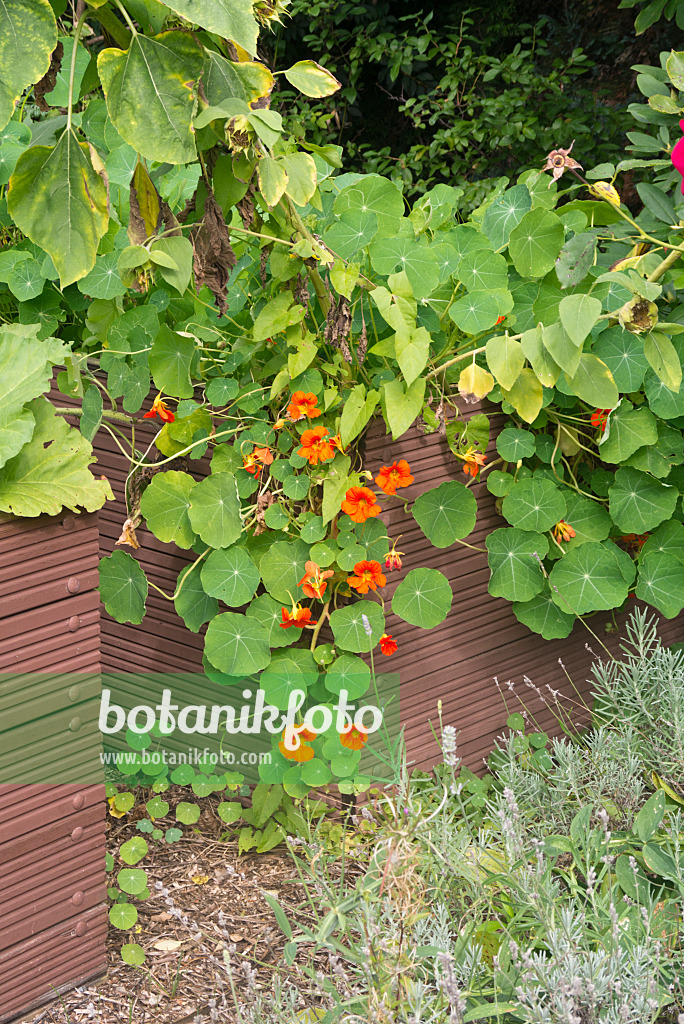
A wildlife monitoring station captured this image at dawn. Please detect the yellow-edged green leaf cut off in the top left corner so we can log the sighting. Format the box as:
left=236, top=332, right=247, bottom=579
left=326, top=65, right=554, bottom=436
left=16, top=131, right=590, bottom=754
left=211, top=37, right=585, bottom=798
left=0, top=0, right=57, bottom=128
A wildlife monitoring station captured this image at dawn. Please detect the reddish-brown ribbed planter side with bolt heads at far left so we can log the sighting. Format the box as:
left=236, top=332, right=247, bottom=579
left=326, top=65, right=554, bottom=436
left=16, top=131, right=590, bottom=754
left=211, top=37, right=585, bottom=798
left=0, top=513, right=106, bottom=1022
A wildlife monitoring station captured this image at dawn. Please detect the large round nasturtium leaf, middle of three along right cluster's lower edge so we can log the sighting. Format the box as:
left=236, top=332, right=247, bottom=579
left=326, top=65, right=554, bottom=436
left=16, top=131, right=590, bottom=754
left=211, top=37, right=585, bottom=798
left=549, top=542, right=630, bottom=615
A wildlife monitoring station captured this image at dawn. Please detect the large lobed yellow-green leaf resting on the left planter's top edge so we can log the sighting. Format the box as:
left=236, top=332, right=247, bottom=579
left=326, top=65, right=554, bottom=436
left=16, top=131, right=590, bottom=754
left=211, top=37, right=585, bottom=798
left=0, top=395, right=113, bottom=518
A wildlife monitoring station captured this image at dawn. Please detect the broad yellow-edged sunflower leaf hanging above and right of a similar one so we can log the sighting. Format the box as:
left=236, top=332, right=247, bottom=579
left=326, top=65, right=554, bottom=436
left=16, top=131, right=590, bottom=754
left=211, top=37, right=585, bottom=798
left=97, top=32, right=202, bottom=164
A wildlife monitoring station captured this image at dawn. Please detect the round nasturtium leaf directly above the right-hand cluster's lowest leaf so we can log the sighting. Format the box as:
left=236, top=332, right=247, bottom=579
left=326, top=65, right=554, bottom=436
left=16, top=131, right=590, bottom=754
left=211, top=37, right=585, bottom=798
left=484, top=527, right=549, bottom=601
